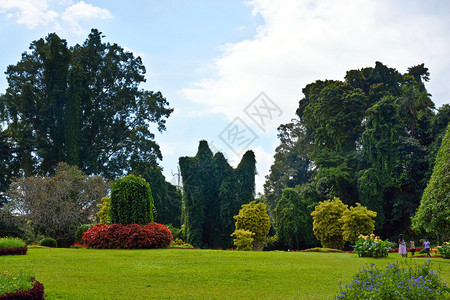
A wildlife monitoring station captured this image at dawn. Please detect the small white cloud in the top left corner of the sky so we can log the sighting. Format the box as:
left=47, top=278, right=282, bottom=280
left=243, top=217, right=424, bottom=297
left=0, top=0, right=112, bottom=35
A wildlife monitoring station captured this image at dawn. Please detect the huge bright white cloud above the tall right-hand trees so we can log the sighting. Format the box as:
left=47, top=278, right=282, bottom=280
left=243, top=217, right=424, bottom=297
left=182, top=0, right=450, bottom=129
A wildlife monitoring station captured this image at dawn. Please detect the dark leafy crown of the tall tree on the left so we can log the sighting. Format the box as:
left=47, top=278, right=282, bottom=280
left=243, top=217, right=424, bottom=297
left=0, top=29, right=173, bottom=183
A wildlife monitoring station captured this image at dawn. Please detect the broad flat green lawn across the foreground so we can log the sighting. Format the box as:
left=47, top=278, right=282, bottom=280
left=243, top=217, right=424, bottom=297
left=0, top=248, right=450, bottom=299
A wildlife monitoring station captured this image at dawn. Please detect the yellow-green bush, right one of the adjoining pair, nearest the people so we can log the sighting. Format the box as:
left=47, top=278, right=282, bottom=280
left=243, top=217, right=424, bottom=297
left=339, top=203, right=377, bottom=243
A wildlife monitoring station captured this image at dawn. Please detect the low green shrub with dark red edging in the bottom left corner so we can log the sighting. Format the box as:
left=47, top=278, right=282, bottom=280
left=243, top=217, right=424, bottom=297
left=0, top=271, right=44, bottom=300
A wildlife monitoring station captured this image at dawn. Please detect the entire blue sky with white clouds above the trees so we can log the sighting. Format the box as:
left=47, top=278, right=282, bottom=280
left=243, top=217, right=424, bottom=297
left=0, top=0, right=450, bottom=192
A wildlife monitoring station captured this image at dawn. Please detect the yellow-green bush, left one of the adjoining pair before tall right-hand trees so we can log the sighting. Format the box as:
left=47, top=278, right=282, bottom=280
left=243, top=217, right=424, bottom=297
left=311, top=198, right=348, bottom=250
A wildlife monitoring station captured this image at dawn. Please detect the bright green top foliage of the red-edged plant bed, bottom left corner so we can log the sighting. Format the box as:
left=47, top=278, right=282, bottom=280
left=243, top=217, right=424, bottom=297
left=0, top=271, right=34, bottom=299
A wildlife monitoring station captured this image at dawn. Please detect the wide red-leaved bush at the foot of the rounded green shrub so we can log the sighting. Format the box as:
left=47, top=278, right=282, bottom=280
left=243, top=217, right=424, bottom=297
left=83, top=223, right=173, bottom=249
